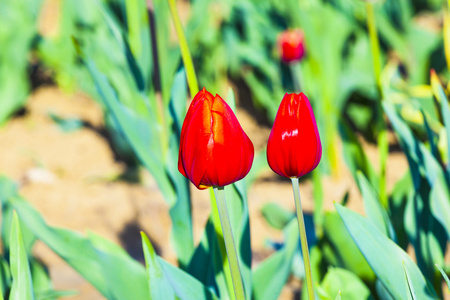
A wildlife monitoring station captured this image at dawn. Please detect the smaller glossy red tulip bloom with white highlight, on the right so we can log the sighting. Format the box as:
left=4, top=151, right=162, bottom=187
left=267, top=93, right=322, bottom=178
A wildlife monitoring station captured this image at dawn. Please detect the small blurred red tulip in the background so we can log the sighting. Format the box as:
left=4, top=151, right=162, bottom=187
left=278, top=29, right=305, bottom=63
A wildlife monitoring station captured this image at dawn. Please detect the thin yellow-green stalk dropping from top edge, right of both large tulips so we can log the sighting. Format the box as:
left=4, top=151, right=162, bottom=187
left=366, top=1, right=389, bottom=207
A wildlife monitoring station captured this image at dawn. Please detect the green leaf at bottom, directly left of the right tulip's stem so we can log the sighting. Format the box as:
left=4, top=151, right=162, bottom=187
left=253, top=218, right=299, bottom=300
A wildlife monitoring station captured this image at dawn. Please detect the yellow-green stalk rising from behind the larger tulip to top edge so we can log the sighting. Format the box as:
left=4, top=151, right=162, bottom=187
left=167, top=0, right=199, bottom=97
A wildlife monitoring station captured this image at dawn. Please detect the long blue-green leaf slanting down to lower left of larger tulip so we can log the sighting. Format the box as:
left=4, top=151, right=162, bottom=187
left=86, top=60, right=194, bottom=267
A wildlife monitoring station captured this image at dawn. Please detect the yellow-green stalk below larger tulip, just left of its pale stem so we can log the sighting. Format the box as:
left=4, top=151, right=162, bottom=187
left=208, top=188, right=235, bottom=300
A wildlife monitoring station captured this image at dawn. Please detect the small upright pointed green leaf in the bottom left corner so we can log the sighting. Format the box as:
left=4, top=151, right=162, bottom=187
left=9, top=212, right=34, bottom=300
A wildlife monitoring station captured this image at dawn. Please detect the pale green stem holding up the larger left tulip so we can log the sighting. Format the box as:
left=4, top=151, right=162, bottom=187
left=214, top=186, right=245, bottom=300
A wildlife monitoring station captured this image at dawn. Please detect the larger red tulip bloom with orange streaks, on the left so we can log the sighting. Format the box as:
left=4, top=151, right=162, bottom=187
left=178, top=88, right=254, bottom=189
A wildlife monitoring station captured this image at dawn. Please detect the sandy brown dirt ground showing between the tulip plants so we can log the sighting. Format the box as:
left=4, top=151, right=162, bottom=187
left=0, top=87, right=426, bottom=300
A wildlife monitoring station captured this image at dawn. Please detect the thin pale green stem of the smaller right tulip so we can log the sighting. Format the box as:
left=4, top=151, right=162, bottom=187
left=291, top=177, right=314, bottom=300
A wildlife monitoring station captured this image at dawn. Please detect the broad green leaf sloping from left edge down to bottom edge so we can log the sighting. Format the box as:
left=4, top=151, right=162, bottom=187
left=2, top=179, right=149, bottom=299
